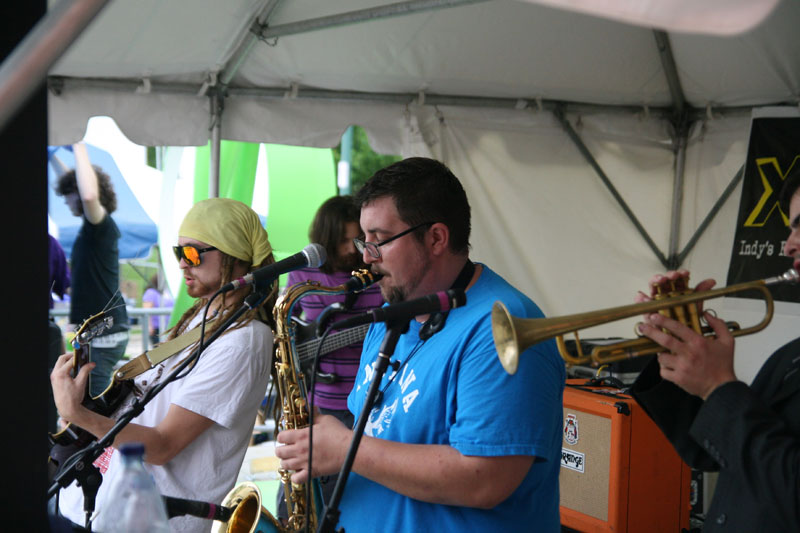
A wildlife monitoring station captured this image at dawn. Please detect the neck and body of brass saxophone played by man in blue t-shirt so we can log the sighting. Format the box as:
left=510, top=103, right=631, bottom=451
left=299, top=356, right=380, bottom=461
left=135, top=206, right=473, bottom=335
left=273, top=270, right=381, bottom=532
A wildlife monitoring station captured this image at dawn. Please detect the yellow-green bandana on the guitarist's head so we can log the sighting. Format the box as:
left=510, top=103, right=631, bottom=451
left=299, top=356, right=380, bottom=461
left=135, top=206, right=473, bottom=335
left=178, top=198, right=272, bottom=267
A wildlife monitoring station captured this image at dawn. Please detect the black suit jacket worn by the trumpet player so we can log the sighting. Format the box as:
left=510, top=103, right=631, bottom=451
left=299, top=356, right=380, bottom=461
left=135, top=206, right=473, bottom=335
left=632, top=339, right=800, bottom=531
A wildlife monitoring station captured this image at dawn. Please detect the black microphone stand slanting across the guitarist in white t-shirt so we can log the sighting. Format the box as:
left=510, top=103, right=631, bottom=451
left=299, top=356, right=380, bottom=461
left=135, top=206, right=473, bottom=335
left=47, top=287, right=269, bottom=531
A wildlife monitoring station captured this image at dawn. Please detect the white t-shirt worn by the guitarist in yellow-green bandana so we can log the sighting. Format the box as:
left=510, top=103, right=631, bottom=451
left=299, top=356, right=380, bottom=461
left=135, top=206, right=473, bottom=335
left=59, top=316, right=273, bottom=532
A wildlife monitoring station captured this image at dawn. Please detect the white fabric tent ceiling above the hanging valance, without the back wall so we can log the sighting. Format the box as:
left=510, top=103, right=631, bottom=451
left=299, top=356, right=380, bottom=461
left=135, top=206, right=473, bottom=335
left=50, top=0, right=800, bottom=147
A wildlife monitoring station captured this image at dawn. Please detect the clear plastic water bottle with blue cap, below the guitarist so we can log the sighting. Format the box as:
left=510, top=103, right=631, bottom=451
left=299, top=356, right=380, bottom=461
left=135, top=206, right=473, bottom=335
left=102, top=442, right=170, bottom=533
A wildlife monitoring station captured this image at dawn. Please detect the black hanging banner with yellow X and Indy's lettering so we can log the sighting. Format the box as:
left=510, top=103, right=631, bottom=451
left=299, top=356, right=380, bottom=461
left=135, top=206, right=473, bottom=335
left=727, top=113, right=800, bottom=302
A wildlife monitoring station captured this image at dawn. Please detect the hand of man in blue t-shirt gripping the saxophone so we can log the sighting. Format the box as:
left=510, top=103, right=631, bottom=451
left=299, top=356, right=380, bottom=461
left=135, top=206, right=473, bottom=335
left=275, top=412, right=353, bottom=483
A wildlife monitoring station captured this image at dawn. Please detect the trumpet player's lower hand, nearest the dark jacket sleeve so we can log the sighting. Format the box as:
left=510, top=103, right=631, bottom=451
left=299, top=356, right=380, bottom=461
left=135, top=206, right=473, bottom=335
left=639, top=312, right=736, bottom=400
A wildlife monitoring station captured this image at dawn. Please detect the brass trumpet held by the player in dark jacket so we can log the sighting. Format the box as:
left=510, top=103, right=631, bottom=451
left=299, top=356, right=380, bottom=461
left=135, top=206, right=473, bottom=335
left=492, top=268, right=800, bottom=374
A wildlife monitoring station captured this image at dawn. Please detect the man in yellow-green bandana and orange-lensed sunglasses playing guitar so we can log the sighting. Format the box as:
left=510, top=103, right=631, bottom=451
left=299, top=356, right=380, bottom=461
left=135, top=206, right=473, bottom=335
left=50, top=198, right=277, bottom=531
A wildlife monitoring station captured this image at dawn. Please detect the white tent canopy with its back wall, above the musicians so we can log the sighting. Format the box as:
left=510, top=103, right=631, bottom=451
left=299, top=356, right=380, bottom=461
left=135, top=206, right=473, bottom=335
left=48, top=0, right=800, bottom=379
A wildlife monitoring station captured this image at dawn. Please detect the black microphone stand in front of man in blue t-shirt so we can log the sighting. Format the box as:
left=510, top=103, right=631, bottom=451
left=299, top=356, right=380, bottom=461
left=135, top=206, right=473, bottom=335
left=318, top=319, right=411, bottom=533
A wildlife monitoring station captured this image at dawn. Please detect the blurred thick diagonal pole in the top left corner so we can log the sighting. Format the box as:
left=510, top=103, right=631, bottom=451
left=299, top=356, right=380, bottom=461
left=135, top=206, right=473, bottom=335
left=0, top=0, right=108, bottom=130
